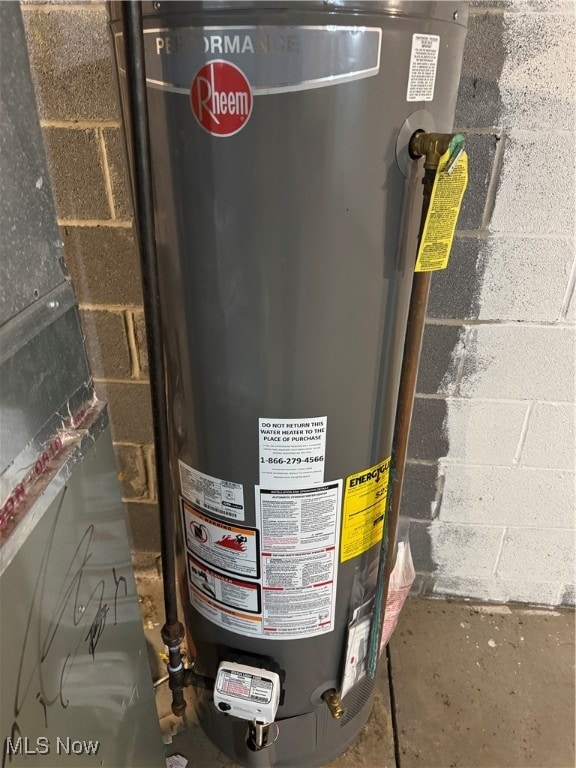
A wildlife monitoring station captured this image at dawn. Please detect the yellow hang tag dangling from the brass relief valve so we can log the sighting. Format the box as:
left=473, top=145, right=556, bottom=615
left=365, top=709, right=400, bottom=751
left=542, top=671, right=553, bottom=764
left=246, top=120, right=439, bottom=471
left=414, top=149, right=468, bottom=272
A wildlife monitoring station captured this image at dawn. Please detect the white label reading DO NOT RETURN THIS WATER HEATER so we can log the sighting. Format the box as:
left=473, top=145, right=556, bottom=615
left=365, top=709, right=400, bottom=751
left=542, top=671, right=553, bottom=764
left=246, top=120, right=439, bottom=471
left=258, top=416, right=327, bottom=488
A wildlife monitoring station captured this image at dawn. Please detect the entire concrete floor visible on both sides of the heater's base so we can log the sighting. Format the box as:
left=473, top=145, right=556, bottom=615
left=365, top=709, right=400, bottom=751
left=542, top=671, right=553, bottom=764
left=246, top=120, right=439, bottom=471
left=139, top=578, right=575, bottom=768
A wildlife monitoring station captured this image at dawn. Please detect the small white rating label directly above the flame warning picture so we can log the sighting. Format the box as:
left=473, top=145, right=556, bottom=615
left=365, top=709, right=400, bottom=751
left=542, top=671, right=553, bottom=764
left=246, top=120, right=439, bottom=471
left=178, top=460, right=244, bottom=520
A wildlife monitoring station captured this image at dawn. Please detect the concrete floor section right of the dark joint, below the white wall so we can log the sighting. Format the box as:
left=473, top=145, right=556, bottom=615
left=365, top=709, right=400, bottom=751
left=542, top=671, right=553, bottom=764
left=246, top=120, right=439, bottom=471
left=391, top=599, right=575, bottom=768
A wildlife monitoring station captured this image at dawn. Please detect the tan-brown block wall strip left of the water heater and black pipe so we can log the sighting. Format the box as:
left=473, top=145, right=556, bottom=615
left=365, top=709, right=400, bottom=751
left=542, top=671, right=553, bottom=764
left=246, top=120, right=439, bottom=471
left=21, top=2, right=159, bottom=554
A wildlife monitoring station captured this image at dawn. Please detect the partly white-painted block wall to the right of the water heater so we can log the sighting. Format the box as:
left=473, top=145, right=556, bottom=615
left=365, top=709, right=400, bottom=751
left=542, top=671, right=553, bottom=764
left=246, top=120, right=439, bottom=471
left=403, top=0, right=576, bottom=605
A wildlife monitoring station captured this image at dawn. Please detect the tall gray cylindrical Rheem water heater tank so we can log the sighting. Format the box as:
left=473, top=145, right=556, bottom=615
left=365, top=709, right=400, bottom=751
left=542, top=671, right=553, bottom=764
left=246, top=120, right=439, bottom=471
left=112, top=2, right=466, bottom=766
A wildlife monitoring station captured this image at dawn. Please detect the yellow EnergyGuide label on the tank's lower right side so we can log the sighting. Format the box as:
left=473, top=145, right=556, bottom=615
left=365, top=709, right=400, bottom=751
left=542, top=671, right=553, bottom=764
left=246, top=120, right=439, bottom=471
left=340, top=458, right=390, bottom=563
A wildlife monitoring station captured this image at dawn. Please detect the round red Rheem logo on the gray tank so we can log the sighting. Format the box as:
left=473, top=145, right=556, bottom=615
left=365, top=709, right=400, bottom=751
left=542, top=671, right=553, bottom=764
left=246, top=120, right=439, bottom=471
left=190, top=59, right=253, bottom=136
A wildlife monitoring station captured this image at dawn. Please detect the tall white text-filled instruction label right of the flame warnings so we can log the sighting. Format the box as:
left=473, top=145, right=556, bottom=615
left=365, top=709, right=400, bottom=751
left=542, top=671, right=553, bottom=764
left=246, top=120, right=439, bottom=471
left=256, top=480, right=342, bottom=639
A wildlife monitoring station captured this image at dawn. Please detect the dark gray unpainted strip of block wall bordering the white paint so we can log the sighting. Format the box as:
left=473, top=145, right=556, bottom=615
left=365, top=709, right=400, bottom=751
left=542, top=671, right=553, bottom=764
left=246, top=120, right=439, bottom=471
left=401, top=11, right=506, bottom=592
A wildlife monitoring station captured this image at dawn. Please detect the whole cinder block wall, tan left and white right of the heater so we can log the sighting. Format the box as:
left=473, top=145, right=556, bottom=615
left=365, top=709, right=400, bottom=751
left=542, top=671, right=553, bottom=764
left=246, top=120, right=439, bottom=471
left=22, top=0, right=576, bottom=605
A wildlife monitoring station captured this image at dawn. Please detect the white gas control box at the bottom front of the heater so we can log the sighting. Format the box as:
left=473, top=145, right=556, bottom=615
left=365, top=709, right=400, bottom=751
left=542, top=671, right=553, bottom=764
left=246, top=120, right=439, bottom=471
left=214, top=661, right=281, bottom=751
